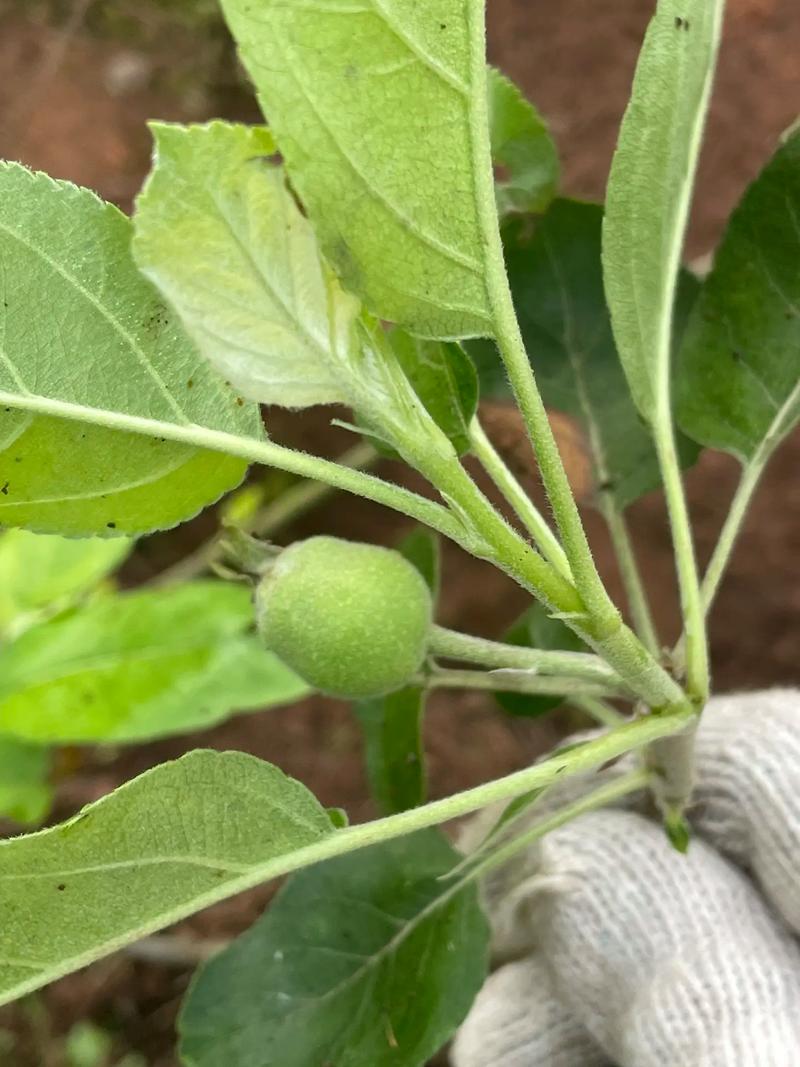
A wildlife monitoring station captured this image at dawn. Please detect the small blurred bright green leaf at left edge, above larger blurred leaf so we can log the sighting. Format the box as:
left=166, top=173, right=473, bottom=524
left=0, top=529, right=132, bottom=631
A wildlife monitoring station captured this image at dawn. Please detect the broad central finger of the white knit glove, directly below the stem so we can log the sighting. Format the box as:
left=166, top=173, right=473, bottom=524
left=532, top=811, right=800, bottom=1067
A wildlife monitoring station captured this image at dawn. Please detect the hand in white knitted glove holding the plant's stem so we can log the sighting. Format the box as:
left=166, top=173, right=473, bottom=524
left=451, top=689, right=800, bottom=1067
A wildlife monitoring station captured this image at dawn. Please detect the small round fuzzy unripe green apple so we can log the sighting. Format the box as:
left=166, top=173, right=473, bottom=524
left=256, top=537, right=432, bottom=700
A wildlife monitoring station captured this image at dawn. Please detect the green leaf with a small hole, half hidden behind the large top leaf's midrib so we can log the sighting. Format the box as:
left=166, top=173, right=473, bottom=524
left=489, top=67, right=561, bottom=219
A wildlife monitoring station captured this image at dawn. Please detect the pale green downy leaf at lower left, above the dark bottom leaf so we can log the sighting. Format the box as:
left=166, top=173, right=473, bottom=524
left=0, top=751, right=334, bottom=1003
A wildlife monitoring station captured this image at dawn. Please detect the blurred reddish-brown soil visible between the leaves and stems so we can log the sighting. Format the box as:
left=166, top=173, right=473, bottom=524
left=0, top=0, right=800, bottom=1067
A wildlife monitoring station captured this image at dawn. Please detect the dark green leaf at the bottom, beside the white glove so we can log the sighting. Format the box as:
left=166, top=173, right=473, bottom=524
left=180, top=831, right=489, bottom=1067
